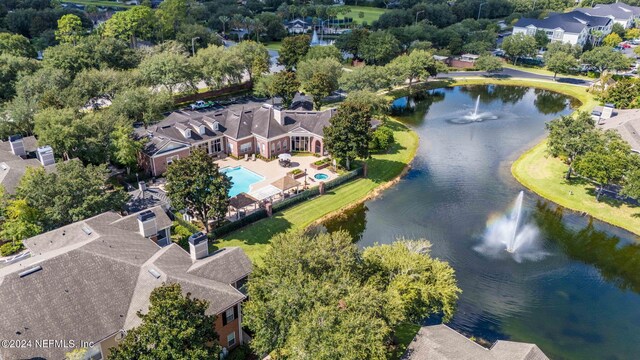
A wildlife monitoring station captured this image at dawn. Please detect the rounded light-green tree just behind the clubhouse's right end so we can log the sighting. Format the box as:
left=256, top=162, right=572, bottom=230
left=297, top=58, right=342, bottom=110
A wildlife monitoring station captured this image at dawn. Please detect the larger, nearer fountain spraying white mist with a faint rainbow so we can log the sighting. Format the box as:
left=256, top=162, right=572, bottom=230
left=475, top=191, right=546, bottom=262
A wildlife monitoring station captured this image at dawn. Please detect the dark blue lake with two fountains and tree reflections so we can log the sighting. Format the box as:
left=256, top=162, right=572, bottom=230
left=324, top=85, right=640, bottom=359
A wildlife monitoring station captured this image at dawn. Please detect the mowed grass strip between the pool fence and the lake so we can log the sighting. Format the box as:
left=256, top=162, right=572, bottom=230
left=214, top=121, right=418, bottom=262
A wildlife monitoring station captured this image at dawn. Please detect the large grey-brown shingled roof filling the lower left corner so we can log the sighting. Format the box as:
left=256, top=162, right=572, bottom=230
left=0, top=208, right=251, bottom=359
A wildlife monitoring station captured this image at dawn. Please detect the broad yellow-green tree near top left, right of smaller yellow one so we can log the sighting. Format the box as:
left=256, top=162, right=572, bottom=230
left=103, top=6, right=155, bottom=48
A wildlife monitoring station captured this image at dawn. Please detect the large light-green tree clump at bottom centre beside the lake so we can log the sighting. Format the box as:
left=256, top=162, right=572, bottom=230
left=243, top=231, right=459, bottom=360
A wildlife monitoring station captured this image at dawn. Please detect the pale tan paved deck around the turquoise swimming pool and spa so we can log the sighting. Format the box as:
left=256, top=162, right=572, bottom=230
left=216, top=155, right=338, bottom=192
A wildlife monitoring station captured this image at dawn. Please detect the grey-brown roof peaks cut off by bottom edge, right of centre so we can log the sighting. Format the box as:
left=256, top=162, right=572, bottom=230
left=402, top=324, right=549, bottom=360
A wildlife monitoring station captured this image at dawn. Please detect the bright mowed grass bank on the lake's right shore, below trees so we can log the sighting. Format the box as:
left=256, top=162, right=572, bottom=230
left=511, top=141, right=640, bottom=234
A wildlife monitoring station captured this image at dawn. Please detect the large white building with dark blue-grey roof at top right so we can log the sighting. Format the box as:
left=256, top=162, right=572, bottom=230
left=513, top=11, right=613, bottom=46
